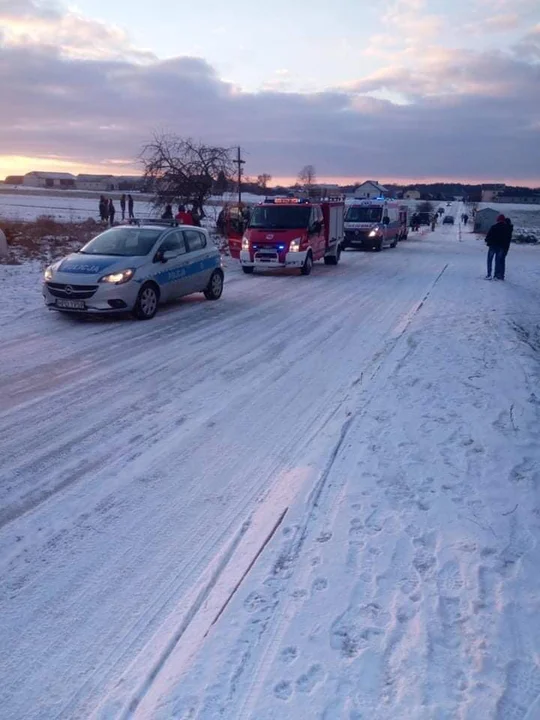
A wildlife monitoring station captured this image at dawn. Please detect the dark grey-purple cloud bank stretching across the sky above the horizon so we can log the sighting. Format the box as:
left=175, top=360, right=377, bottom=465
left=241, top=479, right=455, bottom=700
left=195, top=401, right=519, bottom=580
left=0, top=29, right=540, bottom=180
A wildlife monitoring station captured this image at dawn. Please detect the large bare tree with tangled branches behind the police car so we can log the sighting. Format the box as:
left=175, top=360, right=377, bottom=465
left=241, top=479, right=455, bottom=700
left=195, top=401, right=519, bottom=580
left=140, top=134, right=234, bottom=217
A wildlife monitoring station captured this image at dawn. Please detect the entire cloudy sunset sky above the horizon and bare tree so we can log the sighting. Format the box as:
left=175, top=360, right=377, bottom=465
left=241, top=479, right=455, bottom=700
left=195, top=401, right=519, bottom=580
left=0, top=0, right=540, bottom=185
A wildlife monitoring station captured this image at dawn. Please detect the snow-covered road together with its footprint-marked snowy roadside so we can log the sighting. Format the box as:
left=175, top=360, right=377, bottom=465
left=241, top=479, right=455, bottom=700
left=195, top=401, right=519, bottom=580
left=0, top=207, right=540, bottom=720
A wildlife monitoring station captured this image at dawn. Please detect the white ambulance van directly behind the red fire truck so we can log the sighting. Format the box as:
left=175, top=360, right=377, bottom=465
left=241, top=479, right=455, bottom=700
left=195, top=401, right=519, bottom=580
left=343, top=198, right=407, bottom=251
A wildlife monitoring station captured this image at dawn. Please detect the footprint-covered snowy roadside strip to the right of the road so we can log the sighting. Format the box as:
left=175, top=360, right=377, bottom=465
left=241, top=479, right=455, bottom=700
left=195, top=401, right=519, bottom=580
left=136, top=245, right=540, bottom=720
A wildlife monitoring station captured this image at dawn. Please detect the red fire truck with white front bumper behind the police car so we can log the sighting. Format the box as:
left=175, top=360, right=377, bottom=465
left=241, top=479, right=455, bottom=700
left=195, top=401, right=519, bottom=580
left=240, top=197, right=345, bottom=275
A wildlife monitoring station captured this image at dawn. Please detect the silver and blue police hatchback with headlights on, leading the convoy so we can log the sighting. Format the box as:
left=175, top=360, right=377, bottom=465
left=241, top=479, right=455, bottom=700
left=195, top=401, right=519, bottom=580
left=43, top=221, right=223, bottom=320
